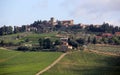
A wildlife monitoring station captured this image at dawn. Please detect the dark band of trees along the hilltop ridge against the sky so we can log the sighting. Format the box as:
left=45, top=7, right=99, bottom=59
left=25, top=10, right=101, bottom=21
left=0, top=20, right=120, bottom=35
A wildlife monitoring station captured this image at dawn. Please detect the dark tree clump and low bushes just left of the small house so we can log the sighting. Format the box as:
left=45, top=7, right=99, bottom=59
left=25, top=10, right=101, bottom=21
left=17, top=38, right=61, bottom=51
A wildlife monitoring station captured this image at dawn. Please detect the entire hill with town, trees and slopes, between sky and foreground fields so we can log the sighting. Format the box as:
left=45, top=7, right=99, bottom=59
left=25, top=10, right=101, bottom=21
left=0, top=17, right=120, bottom=52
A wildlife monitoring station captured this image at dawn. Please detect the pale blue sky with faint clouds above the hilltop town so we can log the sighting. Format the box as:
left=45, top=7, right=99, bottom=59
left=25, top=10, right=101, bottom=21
left=0, top=0, right=120, bottom=26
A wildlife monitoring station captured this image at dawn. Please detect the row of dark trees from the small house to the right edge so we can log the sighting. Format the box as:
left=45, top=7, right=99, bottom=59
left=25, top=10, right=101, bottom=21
left=68, top=36, right=120, bottom=48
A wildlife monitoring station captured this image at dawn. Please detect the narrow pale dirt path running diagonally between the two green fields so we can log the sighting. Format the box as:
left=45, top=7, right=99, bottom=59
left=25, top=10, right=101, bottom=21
left=35, top=53, right=67, bottom=75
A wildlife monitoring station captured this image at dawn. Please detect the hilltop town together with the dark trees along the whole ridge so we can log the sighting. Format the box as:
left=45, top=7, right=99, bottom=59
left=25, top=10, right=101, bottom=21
left=0, top=17, right=120, bottom=35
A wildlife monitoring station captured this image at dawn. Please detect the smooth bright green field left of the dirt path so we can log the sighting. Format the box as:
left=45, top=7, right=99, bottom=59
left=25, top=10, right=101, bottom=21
left=0, top=49, right=62, bottom=75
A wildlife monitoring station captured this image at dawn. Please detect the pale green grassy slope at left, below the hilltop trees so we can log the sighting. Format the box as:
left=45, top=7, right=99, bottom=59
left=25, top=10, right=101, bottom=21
left=0, top=32, right=58, bottom=44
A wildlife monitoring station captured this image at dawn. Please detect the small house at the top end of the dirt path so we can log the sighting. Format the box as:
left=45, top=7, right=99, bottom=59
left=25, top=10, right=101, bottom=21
left=58, top=38, right=72, bottom=52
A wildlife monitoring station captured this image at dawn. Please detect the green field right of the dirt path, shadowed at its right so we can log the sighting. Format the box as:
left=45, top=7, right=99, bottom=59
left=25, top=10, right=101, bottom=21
left=42, top=51, right=120, bottom=75
